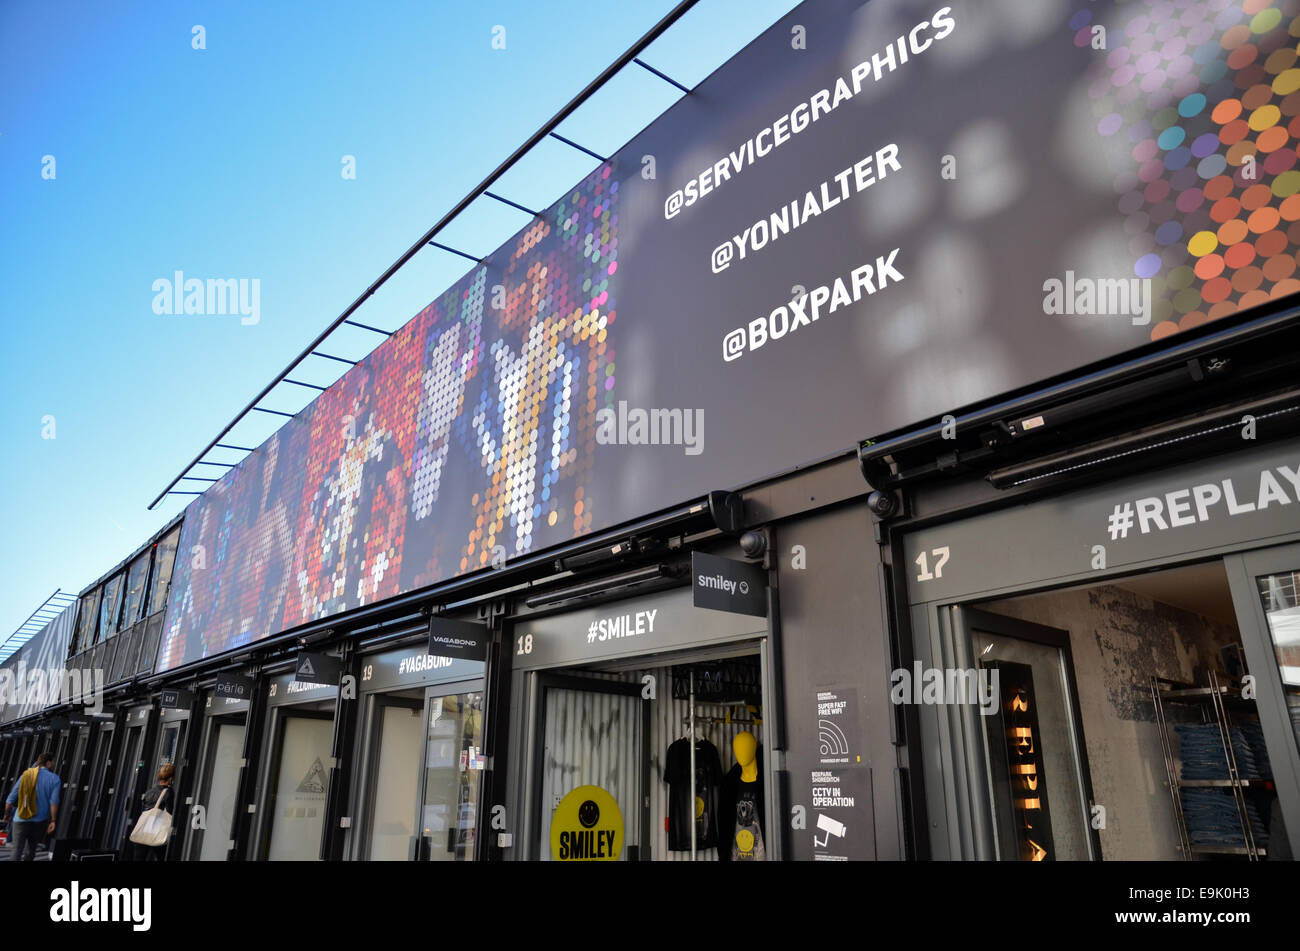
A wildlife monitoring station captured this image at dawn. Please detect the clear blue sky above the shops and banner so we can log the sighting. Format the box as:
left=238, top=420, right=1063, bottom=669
left=0, top=0, right=796, bottom=638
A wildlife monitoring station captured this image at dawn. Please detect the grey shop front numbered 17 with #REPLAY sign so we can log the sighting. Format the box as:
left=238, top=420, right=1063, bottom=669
left=891, top=439, right=1300, bottom=860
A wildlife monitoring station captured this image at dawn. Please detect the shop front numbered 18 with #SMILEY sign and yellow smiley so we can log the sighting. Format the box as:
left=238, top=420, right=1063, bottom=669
left=498, top=571, right=783, bottom=861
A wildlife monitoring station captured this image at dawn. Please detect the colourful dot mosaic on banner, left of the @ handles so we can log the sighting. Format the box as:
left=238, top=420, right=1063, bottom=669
left=156, top=161, right=620, bottom=670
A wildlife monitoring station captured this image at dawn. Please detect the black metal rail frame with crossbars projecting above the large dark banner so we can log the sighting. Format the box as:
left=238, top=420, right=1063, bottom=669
left=148, top=0, right=698, bottom=509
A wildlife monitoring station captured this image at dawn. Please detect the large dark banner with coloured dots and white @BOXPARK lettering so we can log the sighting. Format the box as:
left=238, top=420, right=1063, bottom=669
left=157, top=0, right=1300, bottom=670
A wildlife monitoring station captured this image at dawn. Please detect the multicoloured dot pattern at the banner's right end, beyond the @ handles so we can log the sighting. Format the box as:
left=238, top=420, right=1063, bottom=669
left=1086, top=0, right=1300, bottom=340
